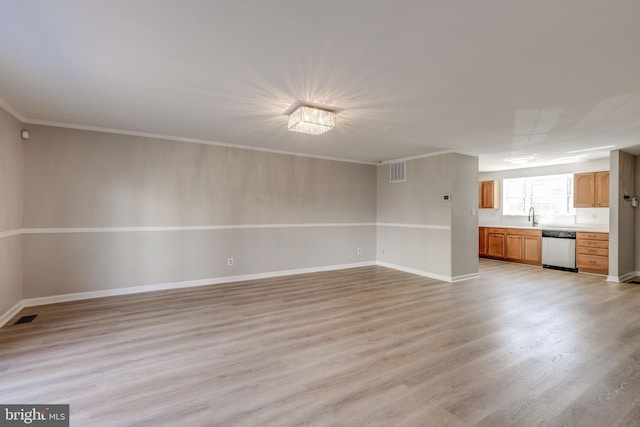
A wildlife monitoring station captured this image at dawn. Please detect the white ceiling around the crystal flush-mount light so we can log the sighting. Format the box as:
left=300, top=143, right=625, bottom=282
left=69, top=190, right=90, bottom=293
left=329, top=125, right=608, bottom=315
left=0, top=0, right=640, bottom=171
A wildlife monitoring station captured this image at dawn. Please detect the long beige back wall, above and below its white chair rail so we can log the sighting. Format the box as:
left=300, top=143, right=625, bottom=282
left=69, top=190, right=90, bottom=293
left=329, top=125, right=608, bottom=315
left=24, top=126, right=376, bottom=298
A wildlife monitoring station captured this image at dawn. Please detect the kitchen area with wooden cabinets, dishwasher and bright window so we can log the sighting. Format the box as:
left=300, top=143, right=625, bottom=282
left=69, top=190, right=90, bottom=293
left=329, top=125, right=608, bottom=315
left=478, top=164, right=608, bottom=276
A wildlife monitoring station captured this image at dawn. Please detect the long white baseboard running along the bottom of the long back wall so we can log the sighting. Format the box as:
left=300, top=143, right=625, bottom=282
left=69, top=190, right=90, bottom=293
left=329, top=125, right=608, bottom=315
left=22, top=261, right=376, bottom=307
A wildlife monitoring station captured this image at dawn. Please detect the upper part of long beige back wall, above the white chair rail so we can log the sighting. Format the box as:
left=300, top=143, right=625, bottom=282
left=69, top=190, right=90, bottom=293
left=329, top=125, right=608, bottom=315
left=25, top=126, right=376, bottom=228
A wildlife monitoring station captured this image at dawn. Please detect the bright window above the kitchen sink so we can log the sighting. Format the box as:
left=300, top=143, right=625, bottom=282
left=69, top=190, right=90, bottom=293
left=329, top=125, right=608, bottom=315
left=502, top=174, right=575, bottom=215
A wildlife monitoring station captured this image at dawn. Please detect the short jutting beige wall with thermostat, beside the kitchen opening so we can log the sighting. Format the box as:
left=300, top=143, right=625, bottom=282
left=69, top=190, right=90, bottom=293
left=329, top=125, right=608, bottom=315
left=377, top=153, right=478, bottom=280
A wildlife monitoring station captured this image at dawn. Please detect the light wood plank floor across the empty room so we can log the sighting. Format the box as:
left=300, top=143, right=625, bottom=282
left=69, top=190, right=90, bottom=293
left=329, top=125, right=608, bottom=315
left=0, top=260, right=640, bottom=427
